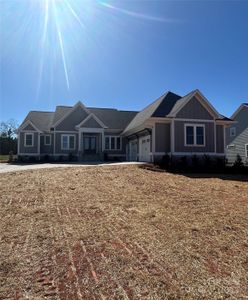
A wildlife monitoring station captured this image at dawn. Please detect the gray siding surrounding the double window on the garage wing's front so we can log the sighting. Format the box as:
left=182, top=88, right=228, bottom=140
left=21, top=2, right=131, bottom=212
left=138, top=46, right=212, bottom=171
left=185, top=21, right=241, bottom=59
left=174, top=121, right=215, bottom=153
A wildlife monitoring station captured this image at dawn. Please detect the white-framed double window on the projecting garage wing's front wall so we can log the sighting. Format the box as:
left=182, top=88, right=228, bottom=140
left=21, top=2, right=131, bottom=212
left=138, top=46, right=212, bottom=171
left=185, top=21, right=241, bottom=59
left=185, top=124, right=205, bottom=146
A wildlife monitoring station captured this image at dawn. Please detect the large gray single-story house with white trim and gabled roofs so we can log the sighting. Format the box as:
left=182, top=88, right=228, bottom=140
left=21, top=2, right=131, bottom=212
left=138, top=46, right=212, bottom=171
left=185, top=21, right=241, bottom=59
left=18, top=90, right=233, bottom=162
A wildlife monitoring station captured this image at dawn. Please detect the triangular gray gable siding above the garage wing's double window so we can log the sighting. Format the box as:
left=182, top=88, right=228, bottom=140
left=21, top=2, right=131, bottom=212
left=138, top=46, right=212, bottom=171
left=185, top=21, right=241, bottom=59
left=176, top=96, right=213, bottom=120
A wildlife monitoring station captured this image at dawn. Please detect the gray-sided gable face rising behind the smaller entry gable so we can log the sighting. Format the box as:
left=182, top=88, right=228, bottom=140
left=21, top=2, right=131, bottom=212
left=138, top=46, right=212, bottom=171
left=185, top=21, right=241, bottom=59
left=56, top=105, right=89, bottom=131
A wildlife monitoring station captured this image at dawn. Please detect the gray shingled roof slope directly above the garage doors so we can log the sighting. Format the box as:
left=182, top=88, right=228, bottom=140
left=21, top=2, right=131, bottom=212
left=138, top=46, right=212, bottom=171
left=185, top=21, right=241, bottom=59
left=124, top=92, right=181, bottom=133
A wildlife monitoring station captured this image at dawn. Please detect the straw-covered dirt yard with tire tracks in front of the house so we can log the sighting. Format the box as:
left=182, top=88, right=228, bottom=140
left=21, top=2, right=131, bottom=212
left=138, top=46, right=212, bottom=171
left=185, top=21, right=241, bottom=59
left=0, top=166, right=248, bottom=300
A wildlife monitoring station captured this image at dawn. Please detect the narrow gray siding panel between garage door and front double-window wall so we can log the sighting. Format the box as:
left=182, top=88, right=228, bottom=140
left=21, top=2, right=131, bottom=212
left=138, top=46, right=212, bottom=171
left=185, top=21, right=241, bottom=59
left=155, top=123, right=170, bottom=153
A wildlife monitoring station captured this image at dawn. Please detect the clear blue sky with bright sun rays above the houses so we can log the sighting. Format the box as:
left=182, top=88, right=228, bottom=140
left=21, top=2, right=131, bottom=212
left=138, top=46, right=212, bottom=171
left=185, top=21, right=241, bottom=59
left=0, top=0, right=248, bottom=123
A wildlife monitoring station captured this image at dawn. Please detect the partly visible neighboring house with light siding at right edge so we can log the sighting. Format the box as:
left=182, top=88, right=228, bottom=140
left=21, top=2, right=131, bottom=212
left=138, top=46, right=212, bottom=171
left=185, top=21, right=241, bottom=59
left=226, top=103, right=248, bottom=164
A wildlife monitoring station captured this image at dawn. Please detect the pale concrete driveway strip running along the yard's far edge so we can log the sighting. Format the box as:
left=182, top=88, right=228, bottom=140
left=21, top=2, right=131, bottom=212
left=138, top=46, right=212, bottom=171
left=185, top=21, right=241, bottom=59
left=0, top=162, right=144, bottom=173
